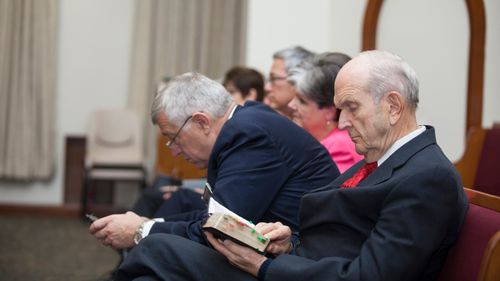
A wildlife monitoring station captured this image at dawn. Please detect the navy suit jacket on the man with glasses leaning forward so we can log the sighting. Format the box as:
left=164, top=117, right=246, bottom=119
left=151, top=102, right=339, bottom=243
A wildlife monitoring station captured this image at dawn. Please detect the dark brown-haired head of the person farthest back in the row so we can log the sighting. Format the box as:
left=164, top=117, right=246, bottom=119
left=222, top=66, right=264, bottom=105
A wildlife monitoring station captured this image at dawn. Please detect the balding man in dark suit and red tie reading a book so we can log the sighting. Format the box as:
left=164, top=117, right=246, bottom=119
left=118, top=51, right=467, bottom=281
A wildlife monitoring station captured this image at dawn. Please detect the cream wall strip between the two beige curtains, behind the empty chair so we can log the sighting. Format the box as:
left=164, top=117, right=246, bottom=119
left=0, top=0, right=134, bottom=205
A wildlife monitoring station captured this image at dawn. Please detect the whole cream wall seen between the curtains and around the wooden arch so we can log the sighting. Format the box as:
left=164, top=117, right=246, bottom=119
left=0, top=0, right=500, bottom=205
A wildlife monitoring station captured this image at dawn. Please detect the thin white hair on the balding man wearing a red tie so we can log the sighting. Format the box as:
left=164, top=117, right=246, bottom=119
left=358, top=50, right=419, bottom=110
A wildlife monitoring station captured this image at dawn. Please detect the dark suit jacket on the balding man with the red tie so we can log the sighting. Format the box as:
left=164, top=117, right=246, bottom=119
left=265, top=127, right=468, bottom=281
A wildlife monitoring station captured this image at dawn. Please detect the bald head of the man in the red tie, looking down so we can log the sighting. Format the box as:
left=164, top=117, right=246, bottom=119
left=334, top=51, right=418, bottom=162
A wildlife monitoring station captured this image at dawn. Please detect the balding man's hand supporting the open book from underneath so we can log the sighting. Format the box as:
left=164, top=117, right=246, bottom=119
left=205, top=232, right=266, bottom=276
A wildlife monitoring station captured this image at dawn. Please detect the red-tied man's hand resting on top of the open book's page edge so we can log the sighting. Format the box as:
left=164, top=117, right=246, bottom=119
left=255, top=222, right=292, bottom=256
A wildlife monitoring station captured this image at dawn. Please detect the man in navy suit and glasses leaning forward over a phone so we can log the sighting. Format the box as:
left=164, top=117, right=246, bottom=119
left=90, top=73, right=339, bottom=249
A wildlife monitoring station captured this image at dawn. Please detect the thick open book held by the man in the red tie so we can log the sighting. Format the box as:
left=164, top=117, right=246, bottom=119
left=203, top=198, right=269, bottom=253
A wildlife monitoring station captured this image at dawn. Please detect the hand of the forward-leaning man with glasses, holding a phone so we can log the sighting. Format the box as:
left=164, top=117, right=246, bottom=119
left=89, top=212, right=147, bottom=250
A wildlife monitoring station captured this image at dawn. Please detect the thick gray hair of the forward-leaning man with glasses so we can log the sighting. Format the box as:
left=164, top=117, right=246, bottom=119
left=151, top=72, right=232, bottom=126
